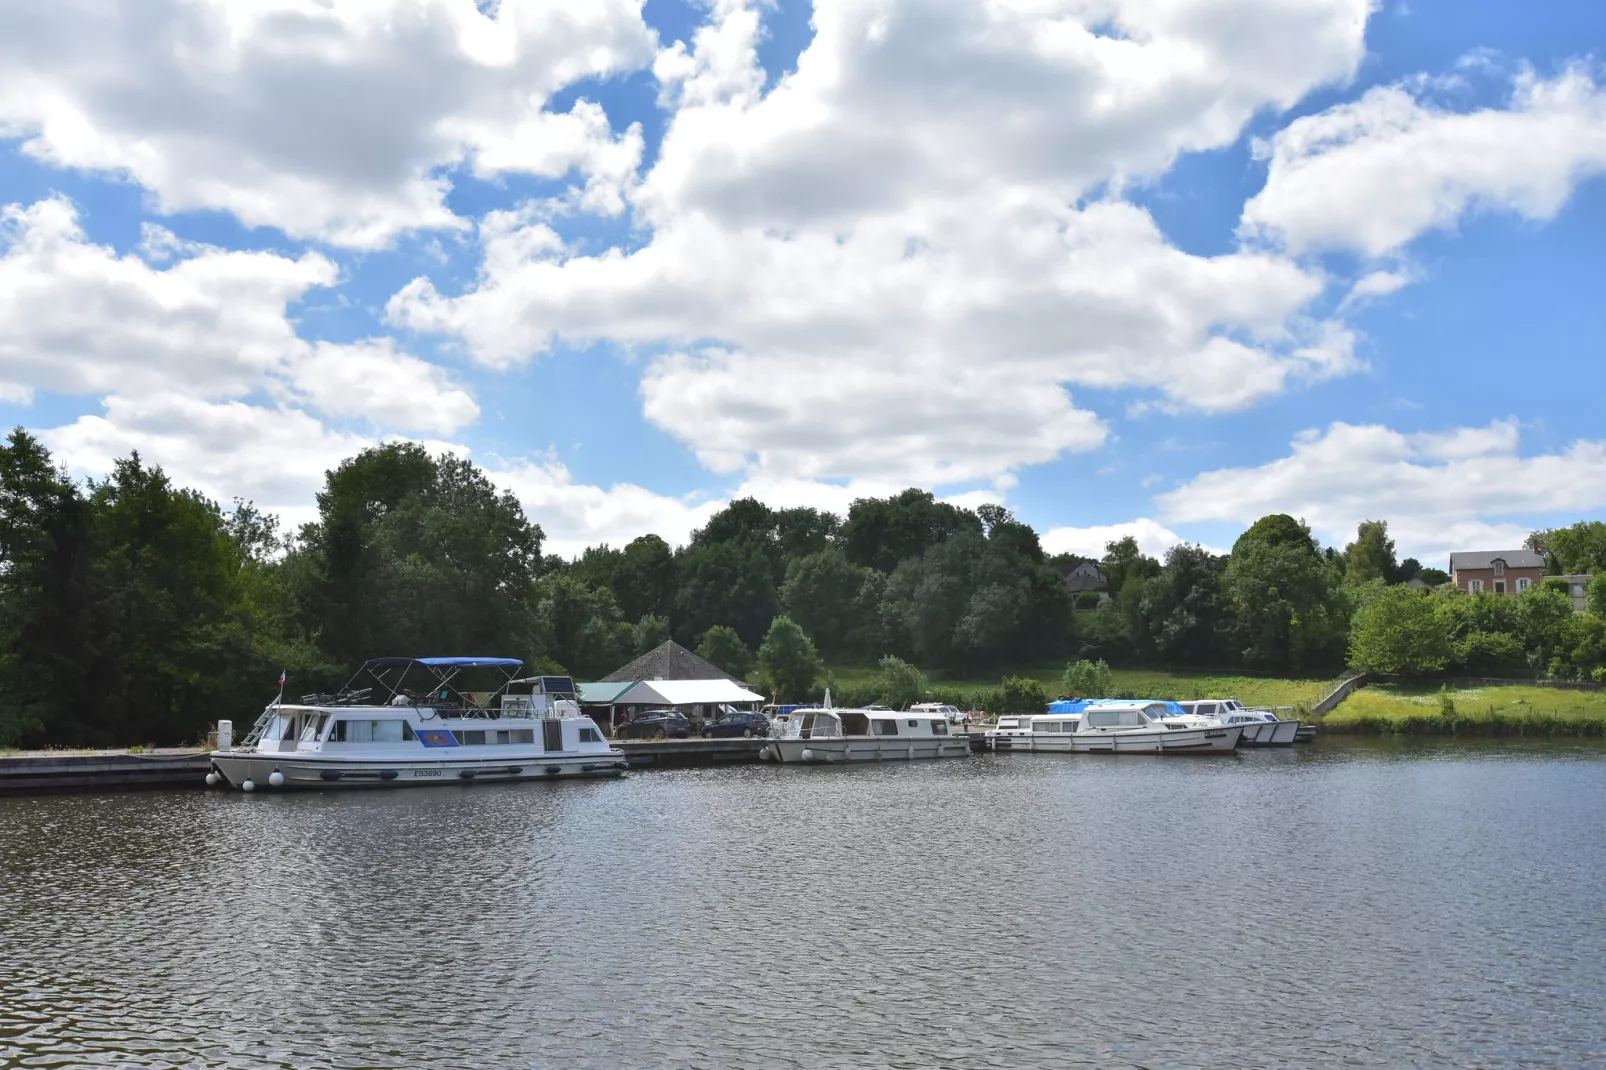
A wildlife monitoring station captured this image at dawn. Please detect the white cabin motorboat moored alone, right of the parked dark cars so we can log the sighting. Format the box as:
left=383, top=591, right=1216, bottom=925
left=758, top=707, right=970, bottom=763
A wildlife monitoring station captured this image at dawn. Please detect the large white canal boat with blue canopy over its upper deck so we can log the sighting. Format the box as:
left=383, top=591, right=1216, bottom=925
left=206, top=657, right=626, bottom=792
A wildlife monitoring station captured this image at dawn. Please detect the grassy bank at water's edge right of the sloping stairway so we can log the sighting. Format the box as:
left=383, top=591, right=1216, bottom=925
left=1322, top=684, right=1606, bottom=736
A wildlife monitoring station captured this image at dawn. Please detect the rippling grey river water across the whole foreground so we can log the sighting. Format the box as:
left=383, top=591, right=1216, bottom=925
left=0, top=741, right=1606, bottom=1068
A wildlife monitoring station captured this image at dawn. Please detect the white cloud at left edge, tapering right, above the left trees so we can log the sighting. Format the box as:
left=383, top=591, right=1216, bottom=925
left=0, top=198, right=479, bottom=434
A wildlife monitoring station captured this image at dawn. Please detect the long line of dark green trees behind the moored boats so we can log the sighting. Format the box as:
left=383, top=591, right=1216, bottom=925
left=0, top=429, right=1606, bottom=745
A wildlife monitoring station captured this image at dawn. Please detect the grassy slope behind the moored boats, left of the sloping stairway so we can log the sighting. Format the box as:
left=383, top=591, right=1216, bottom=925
left=832, top=665, right=1331, bottom=712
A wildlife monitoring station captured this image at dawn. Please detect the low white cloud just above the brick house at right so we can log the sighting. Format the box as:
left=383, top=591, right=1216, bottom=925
left=1156, top=421, right=1606, bottom=564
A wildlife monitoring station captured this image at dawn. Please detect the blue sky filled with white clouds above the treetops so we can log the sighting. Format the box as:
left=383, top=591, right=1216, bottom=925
left=0, top=0, right=1606, bottom=567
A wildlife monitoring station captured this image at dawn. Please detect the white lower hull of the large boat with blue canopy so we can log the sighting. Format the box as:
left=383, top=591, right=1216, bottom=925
left=202, top=750, right=626, bottom=790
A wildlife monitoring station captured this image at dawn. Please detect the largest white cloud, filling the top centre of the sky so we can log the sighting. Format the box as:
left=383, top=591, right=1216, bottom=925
left=389, top=0, right=1372, bottom=487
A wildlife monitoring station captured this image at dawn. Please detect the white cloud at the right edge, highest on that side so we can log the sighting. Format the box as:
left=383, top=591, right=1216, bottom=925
left=1243, top=66, right=1606, bottom=257
